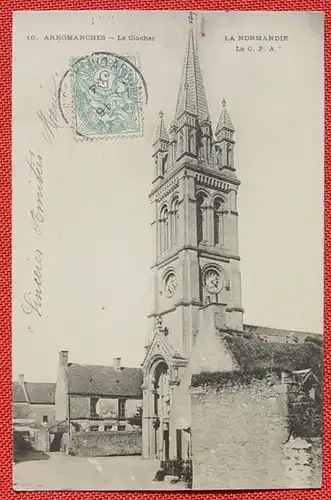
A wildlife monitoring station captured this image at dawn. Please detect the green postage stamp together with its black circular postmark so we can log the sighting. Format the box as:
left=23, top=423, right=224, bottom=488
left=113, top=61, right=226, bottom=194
left=58, top=52, right=148, bottom=139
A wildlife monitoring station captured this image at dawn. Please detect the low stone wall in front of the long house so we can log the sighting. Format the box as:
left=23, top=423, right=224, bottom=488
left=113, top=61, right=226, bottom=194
left=69, top=430, right=142, bottom=457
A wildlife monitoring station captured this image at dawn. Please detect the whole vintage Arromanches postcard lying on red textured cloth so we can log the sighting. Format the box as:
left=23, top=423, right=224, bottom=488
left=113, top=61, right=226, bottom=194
left=12, top=11, right=324, bottom=491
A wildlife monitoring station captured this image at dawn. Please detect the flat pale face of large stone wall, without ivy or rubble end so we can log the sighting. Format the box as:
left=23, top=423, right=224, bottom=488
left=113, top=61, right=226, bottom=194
left=191, top=379, right=288, bottom=489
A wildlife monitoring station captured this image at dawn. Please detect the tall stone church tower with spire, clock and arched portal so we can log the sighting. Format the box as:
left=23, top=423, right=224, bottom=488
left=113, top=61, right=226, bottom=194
left=142, top=15, right=243, bottom=459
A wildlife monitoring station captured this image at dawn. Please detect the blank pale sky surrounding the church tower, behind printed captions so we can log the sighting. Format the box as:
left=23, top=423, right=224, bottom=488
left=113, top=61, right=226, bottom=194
left=13, top=12, right=324, bottom=381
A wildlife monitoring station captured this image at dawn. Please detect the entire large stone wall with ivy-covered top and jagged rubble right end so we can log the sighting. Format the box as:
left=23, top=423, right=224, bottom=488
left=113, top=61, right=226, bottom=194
left=190, top=373, right=321, bottom=489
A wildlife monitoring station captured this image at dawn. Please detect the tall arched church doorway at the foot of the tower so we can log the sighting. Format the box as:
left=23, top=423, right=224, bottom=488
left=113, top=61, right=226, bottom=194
left=151, top=359, right=170, bottom=460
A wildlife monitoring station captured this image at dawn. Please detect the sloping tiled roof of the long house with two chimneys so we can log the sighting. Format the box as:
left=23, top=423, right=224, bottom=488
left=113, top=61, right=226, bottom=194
left=68, top=363, right=143, bottom=398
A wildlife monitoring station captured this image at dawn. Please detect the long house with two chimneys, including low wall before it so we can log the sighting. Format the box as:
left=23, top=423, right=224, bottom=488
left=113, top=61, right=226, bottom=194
left=55, top=351, right=142, bottom=455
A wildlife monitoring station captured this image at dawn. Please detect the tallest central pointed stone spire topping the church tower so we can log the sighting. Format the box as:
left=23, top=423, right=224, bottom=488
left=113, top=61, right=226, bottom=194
left=175, top=16, right=210, bottom=123
